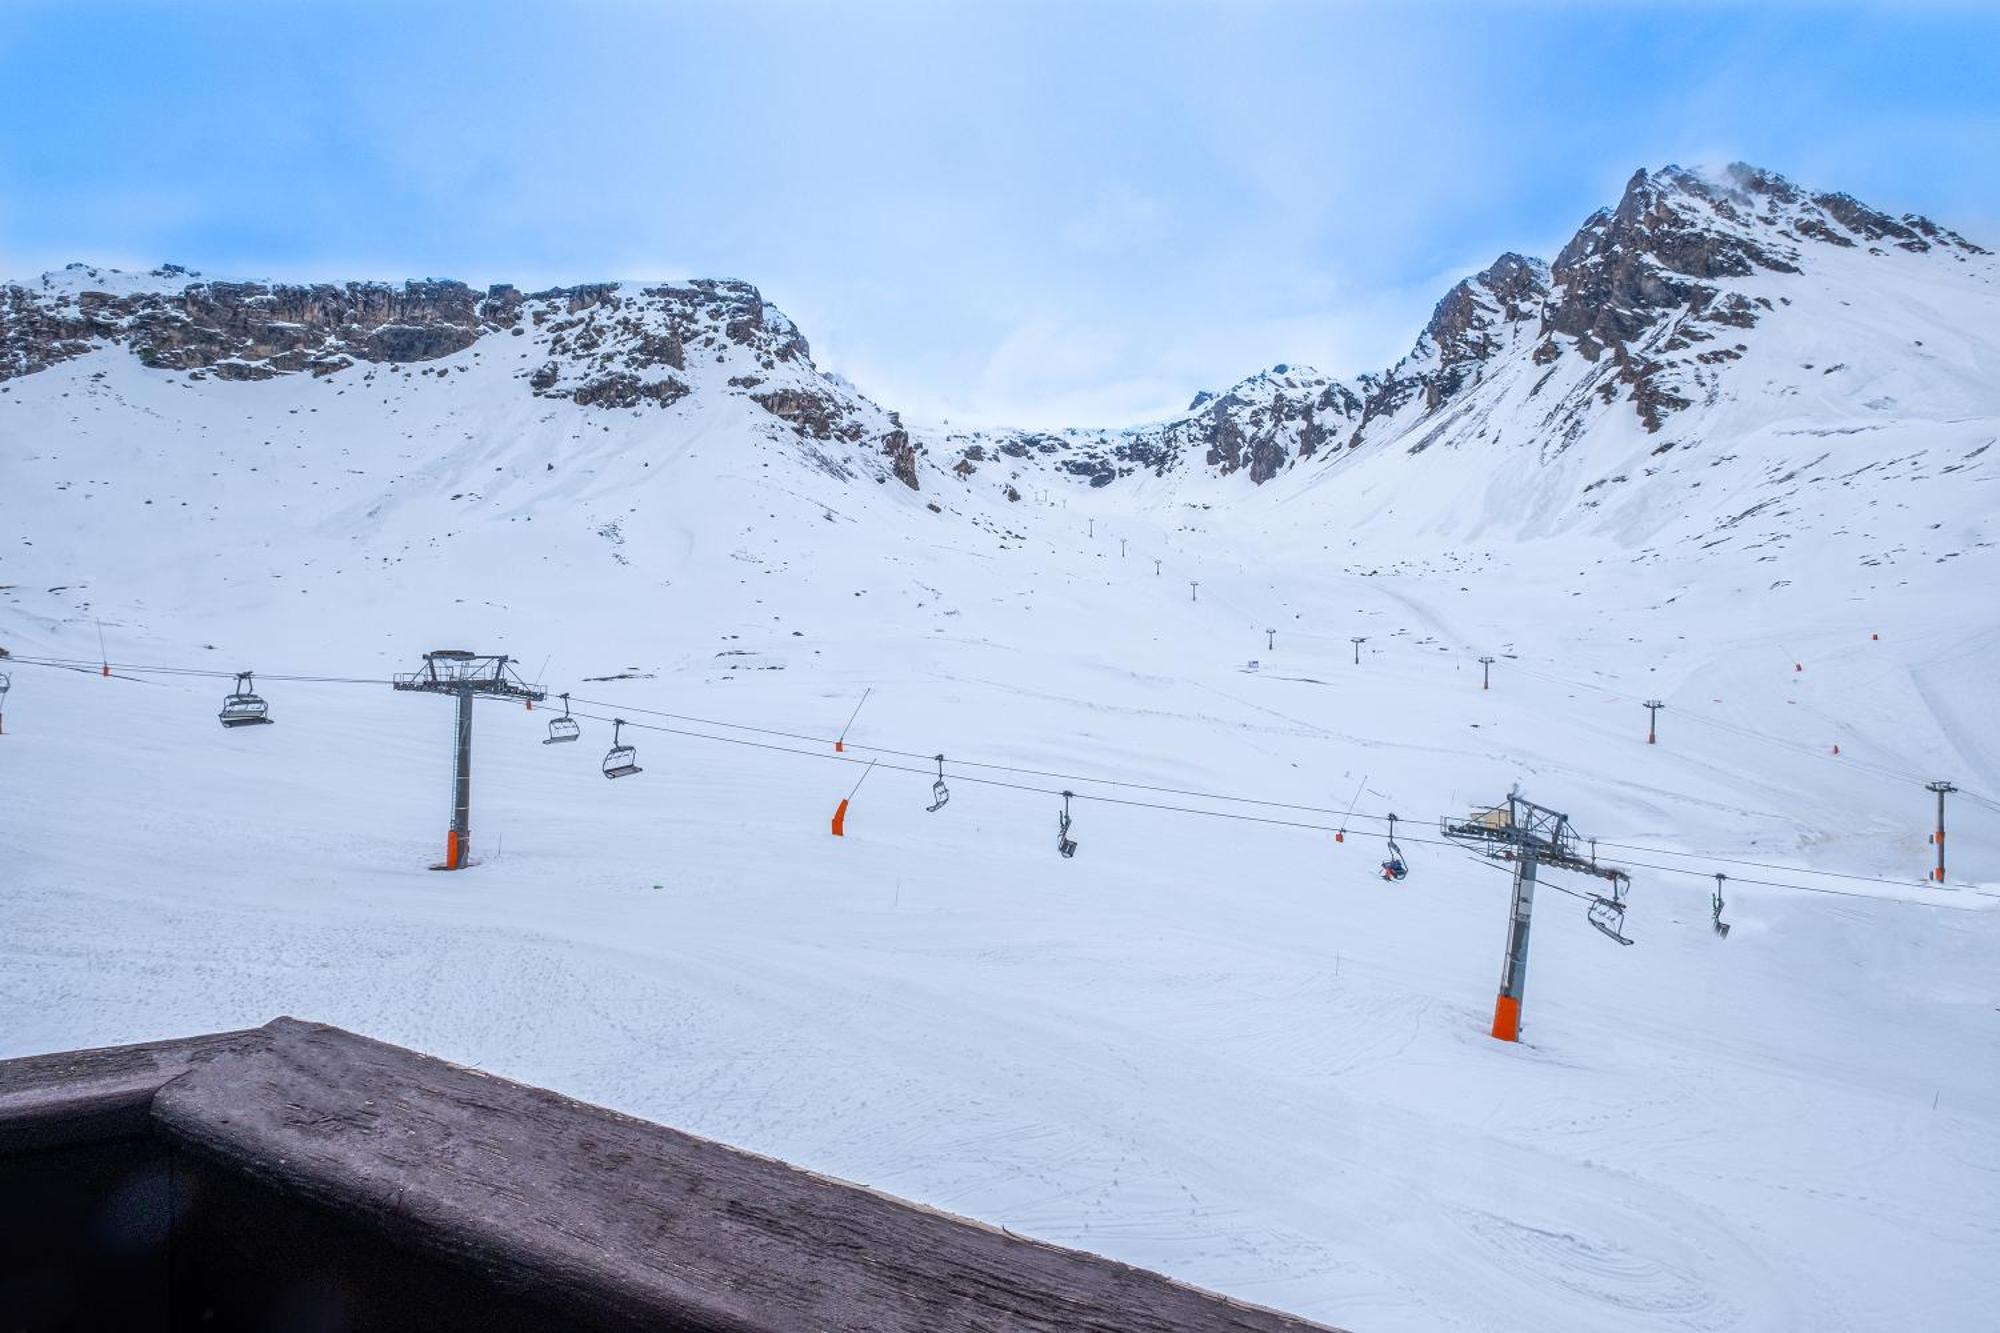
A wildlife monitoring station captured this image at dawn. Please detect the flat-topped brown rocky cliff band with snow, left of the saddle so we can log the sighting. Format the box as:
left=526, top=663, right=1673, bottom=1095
left=0, top=264, right=918, bottom=488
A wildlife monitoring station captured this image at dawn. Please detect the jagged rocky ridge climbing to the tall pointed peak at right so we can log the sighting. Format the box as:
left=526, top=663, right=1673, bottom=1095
left=946, top=162, right=1994, bottom=486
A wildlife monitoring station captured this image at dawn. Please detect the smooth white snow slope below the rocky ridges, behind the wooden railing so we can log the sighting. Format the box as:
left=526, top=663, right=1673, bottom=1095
left=0, top=352, right=2000, bottom=1333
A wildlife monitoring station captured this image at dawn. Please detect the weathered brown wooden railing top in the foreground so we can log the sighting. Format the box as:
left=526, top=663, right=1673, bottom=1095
left=0, top=1019, right=1322, bottom=1333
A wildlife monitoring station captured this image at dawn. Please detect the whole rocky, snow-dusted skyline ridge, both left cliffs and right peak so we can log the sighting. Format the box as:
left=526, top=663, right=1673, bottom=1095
left=0, top=164, right=2000, bottom=500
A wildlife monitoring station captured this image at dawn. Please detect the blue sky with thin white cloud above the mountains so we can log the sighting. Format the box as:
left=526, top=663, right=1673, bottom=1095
left=0, top=0, right=2000, bottom=426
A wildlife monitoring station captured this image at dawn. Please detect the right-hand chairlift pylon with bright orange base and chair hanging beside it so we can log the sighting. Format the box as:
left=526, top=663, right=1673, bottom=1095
left=1440, top=793, right=1632, bottom=1041
